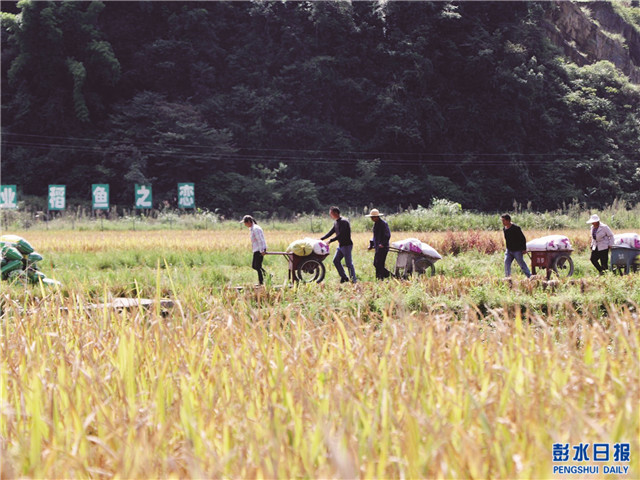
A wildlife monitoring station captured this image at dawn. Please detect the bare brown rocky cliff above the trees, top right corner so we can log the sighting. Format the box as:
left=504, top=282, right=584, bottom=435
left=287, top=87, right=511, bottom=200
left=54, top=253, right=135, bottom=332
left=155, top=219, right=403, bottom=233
left=545, top=1, right=640, bottom=84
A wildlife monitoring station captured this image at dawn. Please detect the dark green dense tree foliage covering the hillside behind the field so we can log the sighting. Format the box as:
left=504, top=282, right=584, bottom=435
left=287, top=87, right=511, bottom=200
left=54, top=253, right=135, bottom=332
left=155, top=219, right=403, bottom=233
left=2, top=0, right=640, bottom=215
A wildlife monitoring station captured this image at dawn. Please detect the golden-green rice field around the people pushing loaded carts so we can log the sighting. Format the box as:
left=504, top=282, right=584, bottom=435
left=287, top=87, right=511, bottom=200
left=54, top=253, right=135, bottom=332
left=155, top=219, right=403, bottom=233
left=0, top=230, right=640, bottom=479
